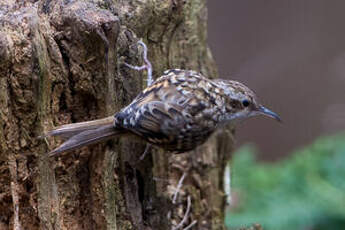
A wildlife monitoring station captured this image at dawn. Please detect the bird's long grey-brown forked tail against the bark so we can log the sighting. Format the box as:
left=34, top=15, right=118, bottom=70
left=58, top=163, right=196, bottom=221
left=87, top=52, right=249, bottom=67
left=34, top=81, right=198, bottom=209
left=41, top=116, right=124, bottom=157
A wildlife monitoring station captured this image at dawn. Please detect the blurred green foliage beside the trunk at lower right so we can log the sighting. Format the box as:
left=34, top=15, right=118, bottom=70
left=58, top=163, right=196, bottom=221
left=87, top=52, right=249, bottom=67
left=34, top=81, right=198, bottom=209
left=226, top=135, right=345, bottom=230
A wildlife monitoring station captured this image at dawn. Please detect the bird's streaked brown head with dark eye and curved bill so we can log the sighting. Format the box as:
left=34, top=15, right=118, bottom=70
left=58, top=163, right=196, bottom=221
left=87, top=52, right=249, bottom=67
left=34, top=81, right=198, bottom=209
left=215, top=79, right=281, bottom=123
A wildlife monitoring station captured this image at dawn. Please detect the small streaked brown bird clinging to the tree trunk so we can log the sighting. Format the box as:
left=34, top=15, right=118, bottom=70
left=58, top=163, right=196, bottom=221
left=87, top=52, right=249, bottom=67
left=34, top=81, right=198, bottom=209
left=44, top=69, right=280, bottom=156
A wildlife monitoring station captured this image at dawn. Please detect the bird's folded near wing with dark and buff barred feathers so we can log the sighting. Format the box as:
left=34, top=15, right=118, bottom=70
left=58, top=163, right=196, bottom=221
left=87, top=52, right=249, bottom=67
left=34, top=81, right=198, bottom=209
left=126, top=101, right=215, bottom=152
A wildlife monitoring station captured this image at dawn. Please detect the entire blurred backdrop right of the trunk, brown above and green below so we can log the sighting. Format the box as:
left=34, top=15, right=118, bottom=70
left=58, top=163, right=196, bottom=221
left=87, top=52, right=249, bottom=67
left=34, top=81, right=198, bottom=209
left=207, top=0, right=345, bottom=230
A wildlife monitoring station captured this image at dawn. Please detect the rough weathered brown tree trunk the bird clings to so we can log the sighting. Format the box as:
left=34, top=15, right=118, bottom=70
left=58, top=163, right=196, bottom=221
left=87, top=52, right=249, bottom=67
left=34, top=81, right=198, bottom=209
left=0, top=0, right=232, bottom=230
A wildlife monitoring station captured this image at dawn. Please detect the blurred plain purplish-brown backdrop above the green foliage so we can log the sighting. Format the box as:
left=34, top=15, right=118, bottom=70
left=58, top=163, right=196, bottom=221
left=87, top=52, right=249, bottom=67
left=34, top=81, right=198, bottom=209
left=208, top=0, right=345, bottom=160
